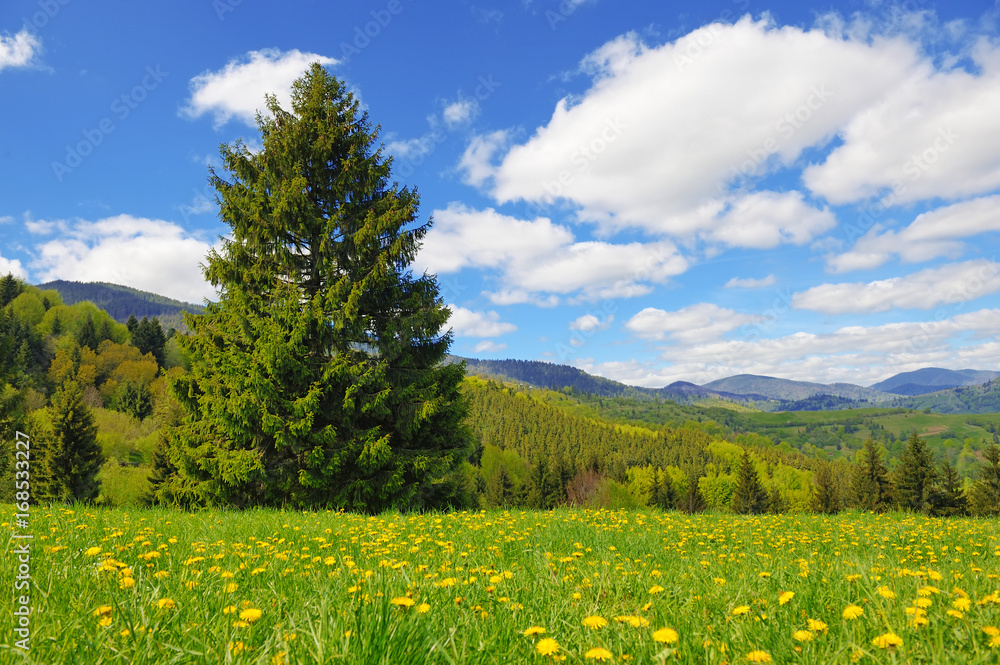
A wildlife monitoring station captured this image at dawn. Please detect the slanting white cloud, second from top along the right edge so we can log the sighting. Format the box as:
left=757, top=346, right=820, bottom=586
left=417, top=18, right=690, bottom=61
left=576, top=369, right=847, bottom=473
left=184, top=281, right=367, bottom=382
left=827, top=196, right=1000, bottom=273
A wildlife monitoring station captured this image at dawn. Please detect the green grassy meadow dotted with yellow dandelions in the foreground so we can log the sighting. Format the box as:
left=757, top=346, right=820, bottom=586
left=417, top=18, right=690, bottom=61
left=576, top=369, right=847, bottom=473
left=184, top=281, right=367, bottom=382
left=0, top=506, right=1000, bottom=664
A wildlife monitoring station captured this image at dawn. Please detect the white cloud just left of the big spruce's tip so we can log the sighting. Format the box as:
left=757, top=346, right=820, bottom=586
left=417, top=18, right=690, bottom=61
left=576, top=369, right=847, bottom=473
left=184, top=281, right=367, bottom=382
left=181, top=49, right=337, bottom=128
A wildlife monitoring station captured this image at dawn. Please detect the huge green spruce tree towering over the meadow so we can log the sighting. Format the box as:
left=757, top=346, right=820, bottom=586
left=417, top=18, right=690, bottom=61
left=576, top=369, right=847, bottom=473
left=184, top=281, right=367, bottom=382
left=166, top=64, right=468, bottom=512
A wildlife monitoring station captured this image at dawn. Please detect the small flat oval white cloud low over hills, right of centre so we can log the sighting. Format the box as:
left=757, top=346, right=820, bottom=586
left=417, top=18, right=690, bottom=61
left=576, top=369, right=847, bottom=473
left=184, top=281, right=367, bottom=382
left=625, top=303, right=756, bottom=344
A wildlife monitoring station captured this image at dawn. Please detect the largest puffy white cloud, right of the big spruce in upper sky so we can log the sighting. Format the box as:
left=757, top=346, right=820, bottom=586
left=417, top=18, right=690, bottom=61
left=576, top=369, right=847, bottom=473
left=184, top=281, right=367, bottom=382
left=482, top=18, right=918, bottom=247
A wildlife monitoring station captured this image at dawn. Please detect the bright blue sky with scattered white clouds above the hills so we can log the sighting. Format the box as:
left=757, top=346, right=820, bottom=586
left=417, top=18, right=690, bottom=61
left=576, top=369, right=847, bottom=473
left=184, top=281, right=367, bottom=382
left=0, top=0, right=1000, bottom=387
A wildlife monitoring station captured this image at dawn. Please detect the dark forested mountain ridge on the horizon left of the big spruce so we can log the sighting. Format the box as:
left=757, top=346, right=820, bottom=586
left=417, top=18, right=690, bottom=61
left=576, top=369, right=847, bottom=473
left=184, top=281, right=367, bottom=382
left=38, top=280, right=205, bottom=331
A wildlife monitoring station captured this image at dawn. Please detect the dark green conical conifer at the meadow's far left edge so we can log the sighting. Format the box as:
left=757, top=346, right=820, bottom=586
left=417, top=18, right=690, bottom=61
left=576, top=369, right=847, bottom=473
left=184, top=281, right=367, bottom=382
left=39, top=381, right=104, bottom=502
